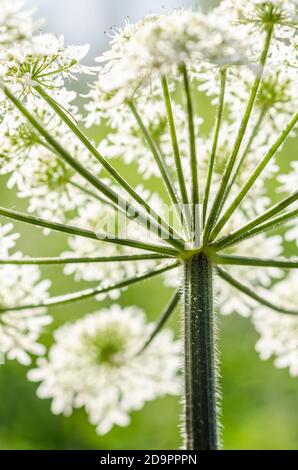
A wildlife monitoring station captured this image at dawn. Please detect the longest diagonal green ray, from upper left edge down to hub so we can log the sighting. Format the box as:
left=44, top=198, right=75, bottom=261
left=3, top=87, right=184, bottom=250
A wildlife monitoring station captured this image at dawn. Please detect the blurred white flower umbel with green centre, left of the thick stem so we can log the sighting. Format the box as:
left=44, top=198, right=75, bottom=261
left=28, top=305, right=180, bottom=434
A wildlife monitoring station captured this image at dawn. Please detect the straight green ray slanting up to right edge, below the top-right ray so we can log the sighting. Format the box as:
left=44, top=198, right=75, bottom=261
left=210, top=113, right=298, bottom=241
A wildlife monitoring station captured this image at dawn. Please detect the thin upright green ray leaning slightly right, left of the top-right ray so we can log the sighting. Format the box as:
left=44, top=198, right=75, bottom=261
left=203, top=67, right=227, bottom=227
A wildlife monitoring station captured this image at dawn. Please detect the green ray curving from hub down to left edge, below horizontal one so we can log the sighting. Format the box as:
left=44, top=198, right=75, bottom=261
left=0, top=263, right=180, bottom=313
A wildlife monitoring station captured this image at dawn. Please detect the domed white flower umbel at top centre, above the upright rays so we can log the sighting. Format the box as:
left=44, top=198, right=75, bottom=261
left=88, top=9, right=246, bottom=110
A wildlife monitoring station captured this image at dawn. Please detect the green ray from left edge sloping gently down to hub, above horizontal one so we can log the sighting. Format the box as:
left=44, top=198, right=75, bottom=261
left=0, top=207, right=178, bottom=256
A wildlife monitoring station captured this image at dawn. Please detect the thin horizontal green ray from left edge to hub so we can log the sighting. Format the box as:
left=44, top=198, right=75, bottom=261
left=0, top=253, right=171, bottom=266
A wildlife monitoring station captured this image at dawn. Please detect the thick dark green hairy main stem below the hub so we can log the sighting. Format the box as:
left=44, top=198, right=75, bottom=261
left=184, top=253, right=218, bottom=450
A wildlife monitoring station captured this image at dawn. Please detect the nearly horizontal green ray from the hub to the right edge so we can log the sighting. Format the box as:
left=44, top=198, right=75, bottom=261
left=213, top=255, right=298, bottom=269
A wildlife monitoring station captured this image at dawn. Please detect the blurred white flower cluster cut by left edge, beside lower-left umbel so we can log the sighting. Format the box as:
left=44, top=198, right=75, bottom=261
left=0, top=224, right=52, bottom=365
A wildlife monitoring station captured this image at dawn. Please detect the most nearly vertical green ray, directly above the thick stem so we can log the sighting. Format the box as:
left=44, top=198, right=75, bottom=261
left=181, top=64, right=200, bottom=244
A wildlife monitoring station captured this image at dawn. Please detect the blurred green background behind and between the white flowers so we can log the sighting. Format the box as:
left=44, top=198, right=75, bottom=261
left=0, top=1, right=298, bottom=450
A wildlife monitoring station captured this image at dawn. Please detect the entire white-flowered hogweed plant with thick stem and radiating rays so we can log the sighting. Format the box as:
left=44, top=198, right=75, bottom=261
left=0, top=0, right=298, bottom=450
